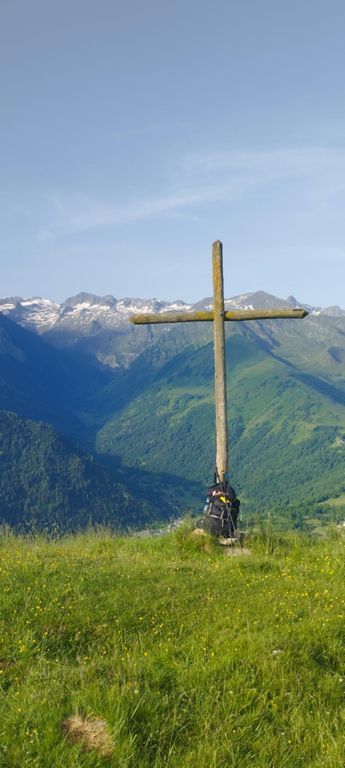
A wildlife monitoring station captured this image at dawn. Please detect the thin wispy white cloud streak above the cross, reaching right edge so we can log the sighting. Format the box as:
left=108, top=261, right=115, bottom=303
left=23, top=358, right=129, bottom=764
left=40, top=147, right=345, bottom=239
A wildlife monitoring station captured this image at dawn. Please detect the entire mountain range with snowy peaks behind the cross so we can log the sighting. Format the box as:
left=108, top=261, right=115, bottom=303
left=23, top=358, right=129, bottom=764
left=0, top=291, right=345, bottom=528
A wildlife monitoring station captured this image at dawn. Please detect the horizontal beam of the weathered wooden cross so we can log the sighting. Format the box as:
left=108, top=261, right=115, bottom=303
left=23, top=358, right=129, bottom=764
left=130, top=309, right=309, bottom=325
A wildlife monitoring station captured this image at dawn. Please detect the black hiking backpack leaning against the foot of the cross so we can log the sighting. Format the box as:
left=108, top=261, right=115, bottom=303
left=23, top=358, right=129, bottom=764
left=204, top=476, right=240, bottom=538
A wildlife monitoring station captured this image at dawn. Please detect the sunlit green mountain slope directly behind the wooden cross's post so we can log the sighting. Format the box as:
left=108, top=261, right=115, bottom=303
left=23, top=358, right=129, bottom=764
left=97, top=334, right=345, bottom=524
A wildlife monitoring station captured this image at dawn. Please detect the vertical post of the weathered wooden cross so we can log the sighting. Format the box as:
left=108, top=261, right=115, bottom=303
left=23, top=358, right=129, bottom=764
left=212, top=240, right=228, bottom=480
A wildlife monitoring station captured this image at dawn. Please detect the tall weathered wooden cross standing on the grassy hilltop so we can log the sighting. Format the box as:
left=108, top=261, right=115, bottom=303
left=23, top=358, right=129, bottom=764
left=130, top=240, right=308, bottom=481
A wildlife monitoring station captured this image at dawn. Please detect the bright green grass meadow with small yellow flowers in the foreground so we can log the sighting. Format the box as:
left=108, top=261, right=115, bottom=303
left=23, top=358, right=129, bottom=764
left=0, top=529, right=345, bottom=768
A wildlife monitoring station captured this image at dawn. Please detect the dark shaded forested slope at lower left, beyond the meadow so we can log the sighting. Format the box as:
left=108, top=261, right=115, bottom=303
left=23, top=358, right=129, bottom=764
left=0, top=411, right=154, bottom=532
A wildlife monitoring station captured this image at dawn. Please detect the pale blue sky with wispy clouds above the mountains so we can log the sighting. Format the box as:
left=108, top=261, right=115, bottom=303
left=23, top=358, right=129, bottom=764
left=0, top=0, right=345, bottom=307
